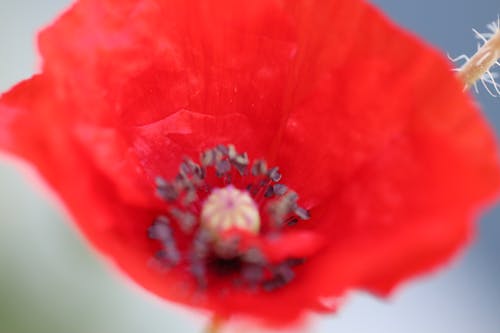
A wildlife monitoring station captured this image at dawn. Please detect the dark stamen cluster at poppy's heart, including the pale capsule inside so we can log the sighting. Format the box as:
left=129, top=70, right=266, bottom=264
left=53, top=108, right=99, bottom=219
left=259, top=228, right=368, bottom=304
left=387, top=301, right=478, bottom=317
left=148, top=145, right=309, bottom=291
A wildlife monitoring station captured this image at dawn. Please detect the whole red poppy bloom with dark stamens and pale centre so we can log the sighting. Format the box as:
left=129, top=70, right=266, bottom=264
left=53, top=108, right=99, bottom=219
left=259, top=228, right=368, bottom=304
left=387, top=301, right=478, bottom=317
left=0, top=0, right=500, bottom=324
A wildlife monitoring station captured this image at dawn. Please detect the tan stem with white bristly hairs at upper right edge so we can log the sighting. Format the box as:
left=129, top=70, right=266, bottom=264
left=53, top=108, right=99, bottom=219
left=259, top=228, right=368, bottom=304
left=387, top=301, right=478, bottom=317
left=448, top=16, right=500, bottom=96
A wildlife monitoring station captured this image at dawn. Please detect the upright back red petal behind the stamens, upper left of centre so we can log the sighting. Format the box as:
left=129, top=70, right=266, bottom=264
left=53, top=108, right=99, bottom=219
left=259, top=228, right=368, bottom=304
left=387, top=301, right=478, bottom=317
left=40, top=0, right=296, bottom=202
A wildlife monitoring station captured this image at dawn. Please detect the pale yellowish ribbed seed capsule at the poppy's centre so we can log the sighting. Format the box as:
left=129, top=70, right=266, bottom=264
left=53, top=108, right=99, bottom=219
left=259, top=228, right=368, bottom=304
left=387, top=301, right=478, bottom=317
left=201, top=185, right=260, bottom=237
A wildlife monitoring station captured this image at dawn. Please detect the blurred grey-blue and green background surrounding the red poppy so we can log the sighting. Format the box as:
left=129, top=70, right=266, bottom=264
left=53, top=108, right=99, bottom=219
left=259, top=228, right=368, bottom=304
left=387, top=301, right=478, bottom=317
left=0, top=0, right=500, bottom=333
